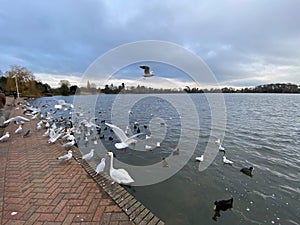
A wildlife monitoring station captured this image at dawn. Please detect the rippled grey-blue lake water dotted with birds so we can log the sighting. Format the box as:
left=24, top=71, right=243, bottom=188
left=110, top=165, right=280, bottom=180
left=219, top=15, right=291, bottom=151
left=33, top=94, right=300, bottom=225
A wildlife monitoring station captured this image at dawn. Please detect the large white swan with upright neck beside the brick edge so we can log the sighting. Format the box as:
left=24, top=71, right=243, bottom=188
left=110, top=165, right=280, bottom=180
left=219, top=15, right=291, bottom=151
left=107, top=152, right=134, bottom=185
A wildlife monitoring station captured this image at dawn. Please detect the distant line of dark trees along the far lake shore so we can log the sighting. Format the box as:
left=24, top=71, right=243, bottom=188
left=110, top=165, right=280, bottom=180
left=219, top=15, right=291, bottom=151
left=0, top=65, right=300, bottom=97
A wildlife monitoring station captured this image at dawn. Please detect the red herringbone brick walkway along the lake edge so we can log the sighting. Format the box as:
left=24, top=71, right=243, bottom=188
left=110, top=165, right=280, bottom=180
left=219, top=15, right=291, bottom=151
left=0, top=98, right=163, bottom=225
